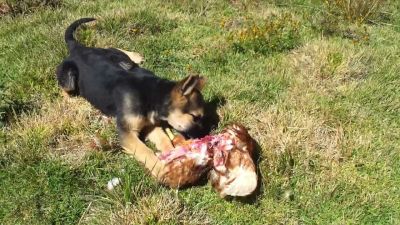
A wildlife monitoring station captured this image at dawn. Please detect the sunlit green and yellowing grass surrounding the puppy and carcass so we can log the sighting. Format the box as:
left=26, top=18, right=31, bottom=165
left=0, top=0, right=400, bottom=224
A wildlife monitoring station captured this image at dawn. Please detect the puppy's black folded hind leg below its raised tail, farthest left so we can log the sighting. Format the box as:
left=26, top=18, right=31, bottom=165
left=56, top=61, right=79, bottom=96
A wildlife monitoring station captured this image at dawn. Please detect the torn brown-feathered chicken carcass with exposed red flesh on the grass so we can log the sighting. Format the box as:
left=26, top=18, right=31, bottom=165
left=159, top=124, right=257, bottom=197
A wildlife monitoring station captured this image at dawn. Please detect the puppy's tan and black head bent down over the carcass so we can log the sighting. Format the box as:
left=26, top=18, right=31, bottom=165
left=167, top=75, right=205, bottom=134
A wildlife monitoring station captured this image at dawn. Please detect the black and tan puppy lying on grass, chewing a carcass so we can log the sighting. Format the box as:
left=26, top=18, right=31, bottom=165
left=56, top=18, right=204, bottom=178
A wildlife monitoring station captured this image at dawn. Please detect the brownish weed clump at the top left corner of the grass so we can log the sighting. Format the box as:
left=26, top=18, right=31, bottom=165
left=2, top=0, right=62, bottom=16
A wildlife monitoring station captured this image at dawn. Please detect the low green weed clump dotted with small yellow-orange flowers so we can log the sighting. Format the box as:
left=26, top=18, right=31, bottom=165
left=228, top=13, right=300, bottom=55
